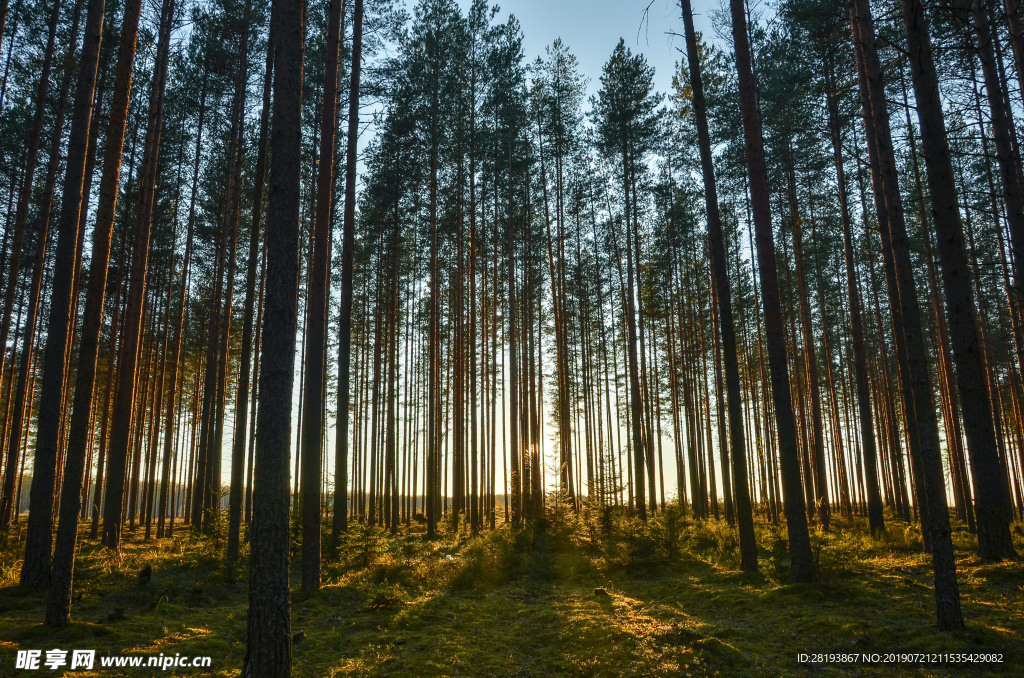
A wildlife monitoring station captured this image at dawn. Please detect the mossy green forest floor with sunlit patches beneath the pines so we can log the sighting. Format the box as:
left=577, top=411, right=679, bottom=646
left=0, top=511, right=1024, bottom=678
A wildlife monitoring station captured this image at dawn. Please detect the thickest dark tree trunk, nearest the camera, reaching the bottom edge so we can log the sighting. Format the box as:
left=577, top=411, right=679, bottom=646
left=242, top=0, right=305, bottom=678
